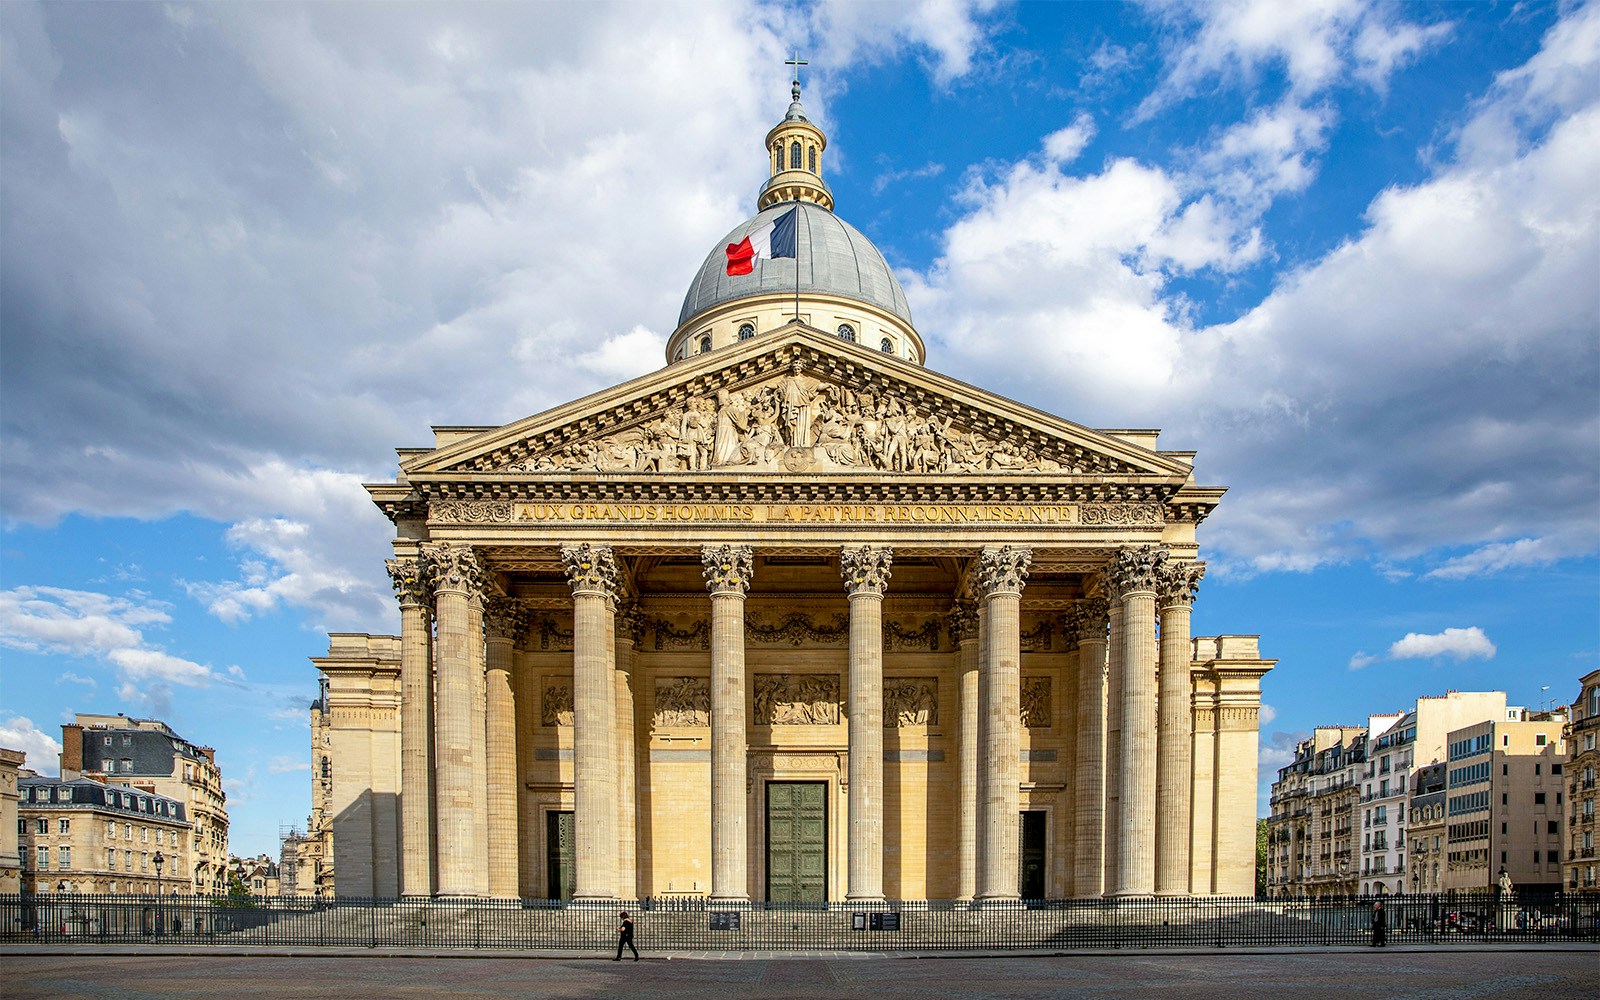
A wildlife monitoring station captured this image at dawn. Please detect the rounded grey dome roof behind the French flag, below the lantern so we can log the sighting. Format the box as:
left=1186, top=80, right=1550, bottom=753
left=678, top=202, right=910, bottom=326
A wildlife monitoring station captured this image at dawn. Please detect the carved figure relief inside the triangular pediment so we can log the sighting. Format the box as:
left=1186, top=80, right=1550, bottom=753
left=494, top=371, right=1114, bottom=475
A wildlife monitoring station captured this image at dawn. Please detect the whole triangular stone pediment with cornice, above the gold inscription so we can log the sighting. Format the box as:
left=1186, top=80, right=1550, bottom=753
left=402, top=323, right=1189, bottom=493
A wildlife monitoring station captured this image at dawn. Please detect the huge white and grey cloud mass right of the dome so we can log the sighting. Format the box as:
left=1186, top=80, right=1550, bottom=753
left=928, top=5, right=1600, bottom=579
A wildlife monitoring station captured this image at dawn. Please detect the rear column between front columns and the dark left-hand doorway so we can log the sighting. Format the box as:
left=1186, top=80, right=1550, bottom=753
left=483, top=597, right=528, bottom=899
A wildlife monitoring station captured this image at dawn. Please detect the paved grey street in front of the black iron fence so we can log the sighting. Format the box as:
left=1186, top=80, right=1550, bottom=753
left=0, top=949, right=1600, bottom=1000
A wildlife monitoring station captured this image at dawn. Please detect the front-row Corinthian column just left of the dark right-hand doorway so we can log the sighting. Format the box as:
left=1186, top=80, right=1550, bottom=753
left=978, top=546, right=1034, bottom=901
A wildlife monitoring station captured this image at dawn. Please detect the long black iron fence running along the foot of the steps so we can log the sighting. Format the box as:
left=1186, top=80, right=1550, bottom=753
left=0, top=893, right=1600, bottom=952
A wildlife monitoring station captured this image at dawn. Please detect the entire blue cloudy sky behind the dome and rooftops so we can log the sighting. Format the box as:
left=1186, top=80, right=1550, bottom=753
left=0, top=0, right=1600, bottom=853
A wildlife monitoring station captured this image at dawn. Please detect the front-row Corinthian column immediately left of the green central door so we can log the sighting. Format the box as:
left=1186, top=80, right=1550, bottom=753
left=701, top=546, right=755, bottom=902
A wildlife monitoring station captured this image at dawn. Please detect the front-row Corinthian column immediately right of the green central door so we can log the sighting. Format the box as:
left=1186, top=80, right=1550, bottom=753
left=838, top=546, right=893, bottom=901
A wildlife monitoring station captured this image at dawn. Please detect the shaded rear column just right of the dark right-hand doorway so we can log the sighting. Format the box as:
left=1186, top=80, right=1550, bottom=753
left=1070, top=597, right=1107, bottom=899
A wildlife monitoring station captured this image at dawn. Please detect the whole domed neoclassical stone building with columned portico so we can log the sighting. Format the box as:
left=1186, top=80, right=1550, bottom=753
left=315, top=83, right=1272, bottom=907
